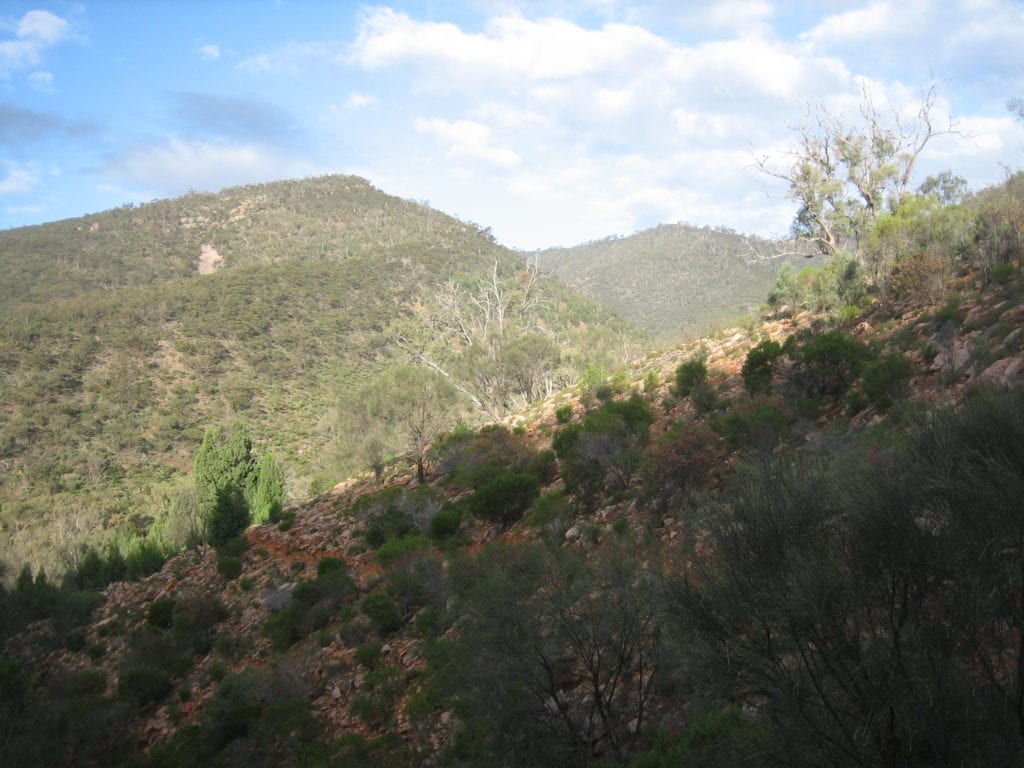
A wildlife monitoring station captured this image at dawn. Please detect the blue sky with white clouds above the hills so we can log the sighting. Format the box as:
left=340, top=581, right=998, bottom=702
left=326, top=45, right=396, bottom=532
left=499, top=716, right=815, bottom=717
left=0, top=0, right=1024, bottom=250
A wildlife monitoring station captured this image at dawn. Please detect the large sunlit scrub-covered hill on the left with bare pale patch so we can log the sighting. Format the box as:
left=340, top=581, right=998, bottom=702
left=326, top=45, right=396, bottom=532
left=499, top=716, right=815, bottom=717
left=0, top=176, right=641, bottom=570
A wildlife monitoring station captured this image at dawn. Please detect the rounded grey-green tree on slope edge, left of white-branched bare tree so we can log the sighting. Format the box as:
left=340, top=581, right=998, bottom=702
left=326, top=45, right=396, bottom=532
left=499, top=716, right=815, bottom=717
left=339, top=366, right=461, bottom=483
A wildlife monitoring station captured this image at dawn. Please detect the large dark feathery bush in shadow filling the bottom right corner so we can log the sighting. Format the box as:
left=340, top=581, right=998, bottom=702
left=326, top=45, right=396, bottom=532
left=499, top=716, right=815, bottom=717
left=672, top=391, right=1024, bottom=766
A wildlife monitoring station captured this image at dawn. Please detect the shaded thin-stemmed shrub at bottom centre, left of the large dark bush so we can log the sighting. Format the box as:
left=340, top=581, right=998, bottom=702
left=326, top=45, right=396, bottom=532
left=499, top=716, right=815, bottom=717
left=438, top=544, right=660, bottom=766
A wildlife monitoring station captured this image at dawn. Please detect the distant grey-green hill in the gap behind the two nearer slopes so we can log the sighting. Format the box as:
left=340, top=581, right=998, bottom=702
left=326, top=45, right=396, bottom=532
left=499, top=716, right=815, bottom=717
left=530, top=224, right=807, bottom=338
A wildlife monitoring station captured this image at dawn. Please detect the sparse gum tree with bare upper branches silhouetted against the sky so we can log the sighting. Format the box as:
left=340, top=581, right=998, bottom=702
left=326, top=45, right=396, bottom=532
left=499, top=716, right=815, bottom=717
left=757, top=83, right=955, bottom=255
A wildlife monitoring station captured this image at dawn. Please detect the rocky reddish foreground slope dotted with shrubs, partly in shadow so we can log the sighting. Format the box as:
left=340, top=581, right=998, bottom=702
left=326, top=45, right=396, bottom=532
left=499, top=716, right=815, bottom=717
left=0, top=171, right=1024, bottom=768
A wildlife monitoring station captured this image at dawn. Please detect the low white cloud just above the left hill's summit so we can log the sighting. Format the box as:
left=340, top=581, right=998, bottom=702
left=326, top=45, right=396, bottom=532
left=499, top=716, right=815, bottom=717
left=102, top=138, right=317, bottom=195
